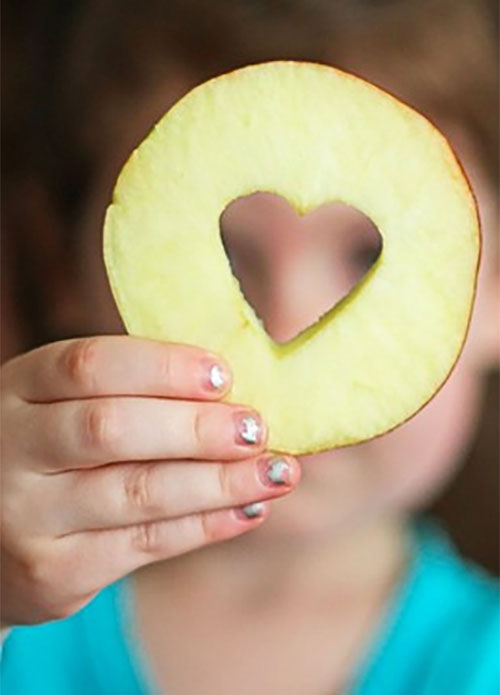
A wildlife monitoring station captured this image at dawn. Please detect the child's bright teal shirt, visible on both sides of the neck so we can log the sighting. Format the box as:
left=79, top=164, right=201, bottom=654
left=1, top=522, right=500, bottom=695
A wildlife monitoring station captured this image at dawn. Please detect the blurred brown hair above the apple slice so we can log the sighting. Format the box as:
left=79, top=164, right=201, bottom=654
left=61, top=0, right=498, bottom=189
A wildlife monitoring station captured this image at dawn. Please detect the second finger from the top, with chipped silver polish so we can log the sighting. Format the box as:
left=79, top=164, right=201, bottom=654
left=24, top=398, right=267, bottom=472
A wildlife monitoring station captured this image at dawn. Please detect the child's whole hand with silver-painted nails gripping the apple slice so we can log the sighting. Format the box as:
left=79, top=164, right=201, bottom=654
left=1, top=336, right=300, bottom=624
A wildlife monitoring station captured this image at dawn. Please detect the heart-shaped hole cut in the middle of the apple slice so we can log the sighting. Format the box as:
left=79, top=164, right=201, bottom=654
left=219, top=191, right=382, bottom=344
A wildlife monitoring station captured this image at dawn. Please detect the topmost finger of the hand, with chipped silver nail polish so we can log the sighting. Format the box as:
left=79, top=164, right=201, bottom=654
left=4, top=335, right=231, bottom=403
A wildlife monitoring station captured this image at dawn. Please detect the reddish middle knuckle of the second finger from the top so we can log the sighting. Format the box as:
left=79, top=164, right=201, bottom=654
left=81, top=400, right=122, bottom=456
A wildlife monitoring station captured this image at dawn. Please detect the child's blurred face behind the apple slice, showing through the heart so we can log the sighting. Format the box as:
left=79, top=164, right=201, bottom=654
left=76, top=102, right=495, bottom=539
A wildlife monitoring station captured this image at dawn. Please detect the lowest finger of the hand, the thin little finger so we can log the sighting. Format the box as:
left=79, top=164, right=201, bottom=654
left=54, top=502, right=270, bottom=595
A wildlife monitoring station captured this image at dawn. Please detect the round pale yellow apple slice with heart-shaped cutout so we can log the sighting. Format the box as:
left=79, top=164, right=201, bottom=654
left=104, top=61, right=480, bottom=454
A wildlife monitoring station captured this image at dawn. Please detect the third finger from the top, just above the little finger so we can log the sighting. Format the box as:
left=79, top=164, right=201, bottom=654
left=49, top=454, right=300, bottom=535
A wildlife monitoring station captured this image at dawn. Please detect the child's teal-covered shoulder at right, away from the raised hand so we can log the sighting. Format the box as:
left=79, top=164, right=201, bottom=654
left=354, top=521, right=500, bottom=695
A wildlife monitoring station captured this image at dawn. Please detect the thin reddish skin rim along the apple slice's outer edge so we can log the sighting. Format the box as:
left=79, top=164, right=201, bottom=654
left=103, top=60, right=483, bottom=456
